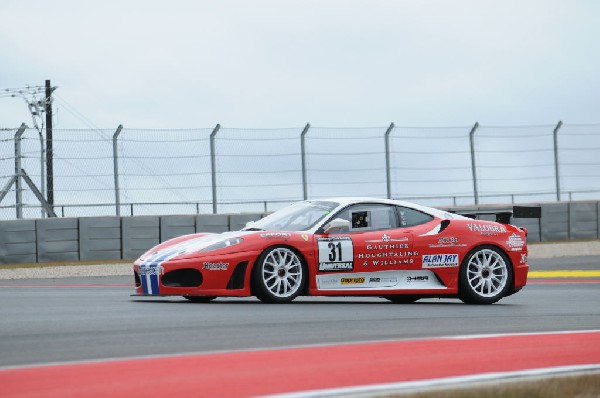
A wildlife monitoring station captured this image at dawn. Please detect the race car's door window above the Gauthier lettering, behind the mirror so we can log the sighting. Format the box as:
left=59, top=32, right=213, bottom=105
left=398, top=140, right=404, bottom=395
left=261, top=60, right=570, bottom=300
left=335, top=204, right=398, bottom=232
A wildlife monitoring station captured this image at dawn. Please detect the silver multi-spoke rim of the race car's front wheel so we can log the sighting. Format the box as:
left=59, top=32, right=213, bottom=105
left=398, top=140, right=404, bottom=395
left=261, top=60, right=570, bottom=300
left=262, top=247, right=303, bottom=298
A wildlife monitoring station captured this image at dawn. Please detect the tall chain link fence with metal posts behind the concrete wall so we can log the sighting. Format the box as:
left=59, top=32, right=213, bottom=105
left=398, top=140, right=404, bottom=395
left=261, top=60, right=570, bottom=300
left=0, top=123, right=600, bottom=220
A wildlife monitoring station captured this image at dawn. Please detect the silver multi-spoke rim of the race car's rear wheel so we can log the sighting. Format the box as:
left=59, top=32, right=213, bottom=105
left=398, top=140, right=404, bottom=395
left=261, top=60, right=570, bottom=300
left=467, top=249, right=508, bottom=297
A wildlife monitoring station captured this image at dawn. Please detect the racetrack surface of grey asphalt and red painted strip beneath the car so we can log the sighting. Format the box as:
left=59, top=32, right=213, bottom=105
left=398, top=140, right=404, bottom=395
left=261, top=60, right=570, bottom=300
left=0, top=256, right=600, bottom=396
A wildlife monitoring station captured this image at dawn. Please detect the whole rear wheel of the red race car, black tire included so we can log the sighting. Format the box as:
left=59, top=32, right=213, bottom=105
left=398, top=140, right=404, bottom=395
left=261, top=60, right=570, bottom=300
left=458, top=246, right=513, bottom=304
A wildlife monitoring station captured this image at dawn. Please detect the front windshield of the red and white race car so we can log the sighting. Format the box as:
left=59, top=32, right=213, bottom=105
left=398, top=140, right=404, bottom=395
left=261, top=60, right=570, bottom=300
left=244, top=200, right=339, bottom=231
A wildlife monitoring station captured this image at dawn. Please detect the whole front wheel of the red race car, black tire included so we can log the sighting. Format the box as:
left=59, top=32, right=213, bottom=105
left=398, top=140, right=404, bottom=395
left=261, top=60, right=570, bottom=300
left=252, top=246, right=308, bottom=303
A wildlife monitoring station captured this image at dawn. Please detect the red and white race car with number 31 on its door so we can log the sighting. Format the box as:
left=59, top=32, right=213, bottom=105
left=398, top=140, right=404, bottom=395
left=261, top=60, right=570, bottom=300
left=134, top=198, right=531, bottom=304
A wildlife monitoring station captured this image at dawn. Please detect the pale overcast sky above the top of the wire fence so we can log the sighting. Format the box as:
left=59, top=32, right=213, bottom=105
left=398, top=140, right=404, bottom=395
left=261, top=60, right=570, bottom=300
left=0, top=0, right=600, bottom=128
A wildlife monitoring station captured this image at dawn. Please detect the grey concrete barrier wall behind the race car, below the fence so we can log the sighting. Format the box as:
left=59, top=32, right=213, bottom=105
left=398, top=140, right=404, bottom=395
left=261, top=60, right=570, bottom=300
left=0, top=201, right=600, bottom=264
